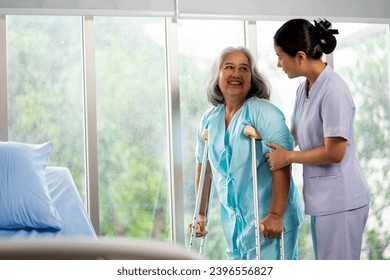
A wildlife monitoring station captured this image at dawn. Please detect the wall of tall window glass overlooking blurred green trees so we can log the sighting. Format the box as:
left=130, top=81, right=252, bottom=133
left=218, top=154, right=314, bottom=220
left=0, top=15, right=390, bottom=259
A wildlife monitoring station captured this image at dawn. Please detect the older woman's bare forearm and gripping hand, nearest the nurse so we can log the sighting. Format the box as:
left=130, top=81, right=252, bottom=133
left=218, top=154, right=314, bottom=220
left=261, top=166, right=291, bottom=238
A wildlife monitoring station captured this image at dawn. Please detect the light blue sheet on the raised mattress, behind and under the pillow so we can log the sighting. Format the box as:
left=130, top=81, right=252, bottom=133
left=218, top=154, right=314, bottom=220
left=0, top=167, right=97, bottom=239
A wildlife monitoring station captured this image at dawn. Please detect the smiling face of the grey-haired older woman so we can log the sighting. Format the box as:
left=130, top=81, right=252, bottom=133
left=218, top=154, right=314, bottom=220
left=218, top=52, right=252, bottom=99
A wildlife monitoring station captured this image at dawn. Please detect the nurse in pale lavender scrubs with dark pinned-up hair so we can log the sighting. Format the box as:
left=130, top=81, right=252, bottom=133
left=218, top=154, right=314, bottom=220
left=266, top=19, right=370, bottom=260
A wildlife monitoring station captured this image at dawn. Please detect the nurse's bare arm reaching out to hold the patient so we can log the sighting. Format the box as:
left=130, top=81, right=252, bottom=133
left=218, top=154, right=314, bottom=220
left=265, top=137, right=347, bottom=172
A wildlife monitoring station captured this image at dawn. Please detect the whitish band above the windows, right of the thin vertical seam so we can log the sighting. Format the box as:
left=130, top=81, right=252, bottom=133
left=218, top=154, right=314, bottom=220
left=179, top=0, right=390, bottom=22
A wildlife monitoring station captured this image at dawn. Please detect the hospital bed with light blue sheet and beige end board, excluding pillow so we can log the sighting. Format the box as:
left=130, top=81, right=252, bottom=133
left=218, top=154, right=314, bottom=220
left=0, top=167, right=198, bottom=260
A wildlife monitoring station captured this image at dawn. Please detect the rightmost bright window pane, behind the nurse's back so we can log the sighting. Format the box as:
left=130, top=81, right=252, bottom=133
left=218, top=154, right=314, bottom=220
left=333, top=23, right=390, bottom=259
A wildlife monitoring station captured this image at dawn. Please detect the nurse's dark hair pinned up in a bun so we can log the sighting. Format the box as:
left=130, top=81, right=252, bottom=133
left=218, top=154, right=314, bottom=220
left=274, top=19, right=338, bottom=59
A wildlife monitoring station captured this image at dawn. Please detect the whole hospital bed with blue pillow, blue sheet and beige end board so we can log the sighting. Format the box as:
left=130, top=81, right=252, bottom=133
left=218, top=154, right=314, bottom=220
left=0, top=142, right=197, bottom=260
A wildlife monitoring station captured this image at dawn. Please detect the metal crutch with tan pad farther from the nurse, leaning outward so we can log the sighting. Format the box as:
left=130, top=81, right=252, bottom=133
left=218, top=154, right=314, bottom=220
left=189, top=130, right=210, bottom=253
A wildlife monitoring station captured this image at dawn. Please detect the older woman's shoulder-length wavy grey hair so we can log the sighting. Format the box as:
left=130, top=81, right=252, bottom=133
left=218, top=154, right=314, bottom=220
left=205, top=47, right=270, bottom=106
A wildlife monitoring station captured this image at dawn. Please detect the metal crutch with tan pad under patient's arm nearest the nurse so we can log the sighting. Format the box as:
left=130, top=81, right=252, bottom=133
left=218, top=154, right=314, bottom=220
left=244, top=125, right=284, bottom=260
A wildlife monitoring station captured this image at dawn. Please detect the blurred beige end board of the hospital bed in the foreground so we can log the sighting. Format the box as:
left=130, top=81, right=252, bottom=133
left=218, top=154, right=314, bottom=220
left=0, top=238, right=198, bottom=260
